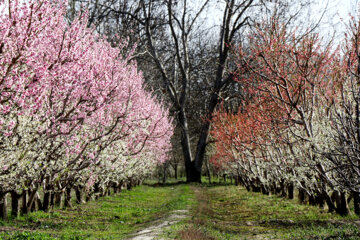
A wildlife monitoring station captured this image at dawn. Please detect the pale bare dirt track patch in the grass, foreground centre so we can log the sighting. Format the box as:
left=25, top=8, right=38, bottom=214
left=128, top=210, right=189, bottom=240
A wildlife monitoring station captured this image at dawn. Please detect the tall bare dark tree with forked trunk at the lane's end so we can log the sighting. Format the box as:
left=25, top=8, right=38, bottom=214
left=67, top=0, right=316, bottom=182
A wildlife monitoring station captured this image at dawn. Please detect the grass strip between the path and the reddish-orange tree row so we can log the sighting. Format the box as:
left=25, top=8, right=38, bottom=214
left=167, top=185, right=360, bottom=240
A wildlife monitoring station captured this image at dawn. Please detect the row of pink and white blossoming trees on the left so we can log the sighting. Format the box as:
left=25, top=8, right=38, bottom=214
left=0, top=0, right=173, bottom=218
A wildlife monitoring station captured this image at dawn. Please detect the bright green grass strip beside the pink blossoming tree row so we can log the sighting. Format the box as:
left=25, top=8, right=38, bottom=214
left=0, top=185, right=192, bottom=240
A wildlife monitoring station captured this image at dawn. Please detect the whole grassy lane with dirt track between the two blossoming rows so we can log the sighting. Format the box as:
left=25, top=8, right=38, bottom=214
left=0, top=183, right=360, bottom=240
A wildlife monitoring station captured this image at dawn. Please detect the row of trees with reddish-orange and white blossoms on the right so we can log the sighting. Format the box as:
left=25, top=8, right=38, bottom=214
left=212, top=18, right=360, bottom=215
